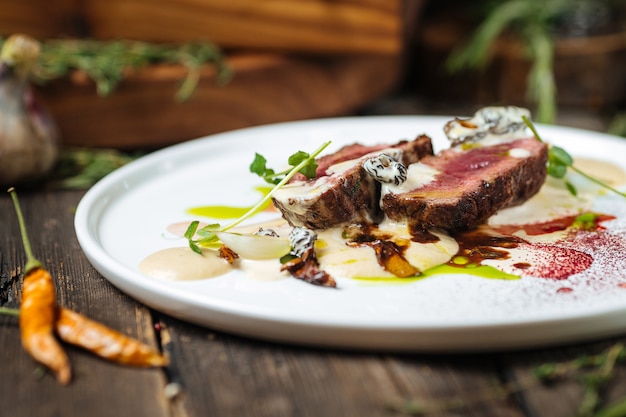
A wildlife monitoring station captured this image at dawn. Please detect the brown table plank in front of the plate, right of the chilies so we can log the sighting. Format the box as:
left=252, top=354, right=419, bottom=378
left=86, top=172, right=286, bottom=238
left=156, top=317, right=522, bottom=417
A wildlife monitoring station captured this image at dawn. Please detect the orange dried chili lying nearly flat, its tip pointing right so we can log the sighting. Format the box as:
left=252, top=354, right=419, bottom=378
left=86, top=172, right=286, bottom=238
left=56, top=308, right=168, bottom=367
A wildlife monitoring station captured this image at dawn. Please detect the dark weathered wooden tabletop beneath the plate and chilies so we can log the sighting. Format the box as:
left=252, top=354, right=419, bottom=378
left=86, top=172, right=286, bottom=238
left=0, top=108, right=626, bottom=417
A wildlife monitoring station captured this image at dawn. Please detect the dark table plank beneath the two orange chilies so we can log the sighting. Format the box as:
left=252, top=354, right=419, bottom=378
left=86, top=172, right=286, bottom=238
left=0, top=190, right=169, bottom=417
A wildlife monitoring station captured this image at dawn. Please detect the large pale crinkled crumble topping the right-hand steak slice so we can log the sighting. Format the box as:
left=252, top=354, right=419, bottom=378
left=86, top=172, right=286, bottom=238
left=444, top=106, right=530, bottom=146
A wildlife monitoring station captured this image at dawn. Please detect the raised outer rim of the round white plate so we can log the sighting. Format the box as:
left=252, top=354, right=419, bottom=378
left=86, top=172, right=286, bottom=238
left=74, top=115, right=626, bottom=351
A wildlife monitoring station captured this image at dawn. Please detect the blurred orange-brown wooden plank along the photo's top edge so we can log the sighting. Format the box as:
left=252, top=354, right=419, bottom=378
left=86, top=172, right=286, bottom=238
left=83, top=0, right=403, bottom=54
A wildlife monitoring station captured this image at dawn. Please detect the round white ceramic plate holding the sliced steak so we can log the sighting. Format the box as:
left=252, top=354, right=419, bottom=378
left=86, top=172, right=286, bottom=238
left=75, top=116, right=626, bottom=352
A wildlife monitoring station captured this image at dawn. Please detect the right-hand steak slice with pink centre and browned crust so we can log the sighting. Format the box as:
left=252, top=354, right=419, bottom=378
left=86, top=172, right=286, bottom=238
left=381, top=138, right=548, bottom=232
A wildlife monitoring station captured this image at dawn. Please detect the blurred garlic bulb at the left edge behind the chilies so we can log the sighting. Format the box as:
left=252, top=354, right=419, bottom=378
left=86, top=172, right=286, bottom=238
left=0, top=35, right=59, bottom=185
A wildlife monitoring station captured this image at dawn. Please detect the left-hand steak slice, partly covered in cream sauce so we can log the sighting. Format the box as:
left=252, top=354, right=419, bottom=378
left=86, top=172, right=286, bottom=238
left=272, top=135, right=433, bottom=230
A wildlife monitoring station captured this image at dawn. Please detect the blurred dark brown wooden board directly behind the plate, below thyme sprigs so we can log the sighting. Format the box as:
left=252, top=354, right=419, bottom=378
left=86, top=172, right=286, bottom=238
left=38, top=54, right=401, bottom=149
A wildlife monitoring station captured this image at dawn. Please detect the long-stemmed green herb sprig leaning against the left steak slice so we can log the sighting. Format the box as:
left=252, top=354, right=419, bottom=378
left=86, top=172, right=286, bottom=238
left=184, top=141, right=330, bottom=255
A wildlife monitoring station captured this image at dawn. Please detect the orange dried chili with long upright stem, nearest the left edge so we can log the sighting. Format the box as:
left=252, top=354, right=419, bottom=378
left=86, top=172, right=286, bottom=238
left=9, top=188, right=72, bottom=385
